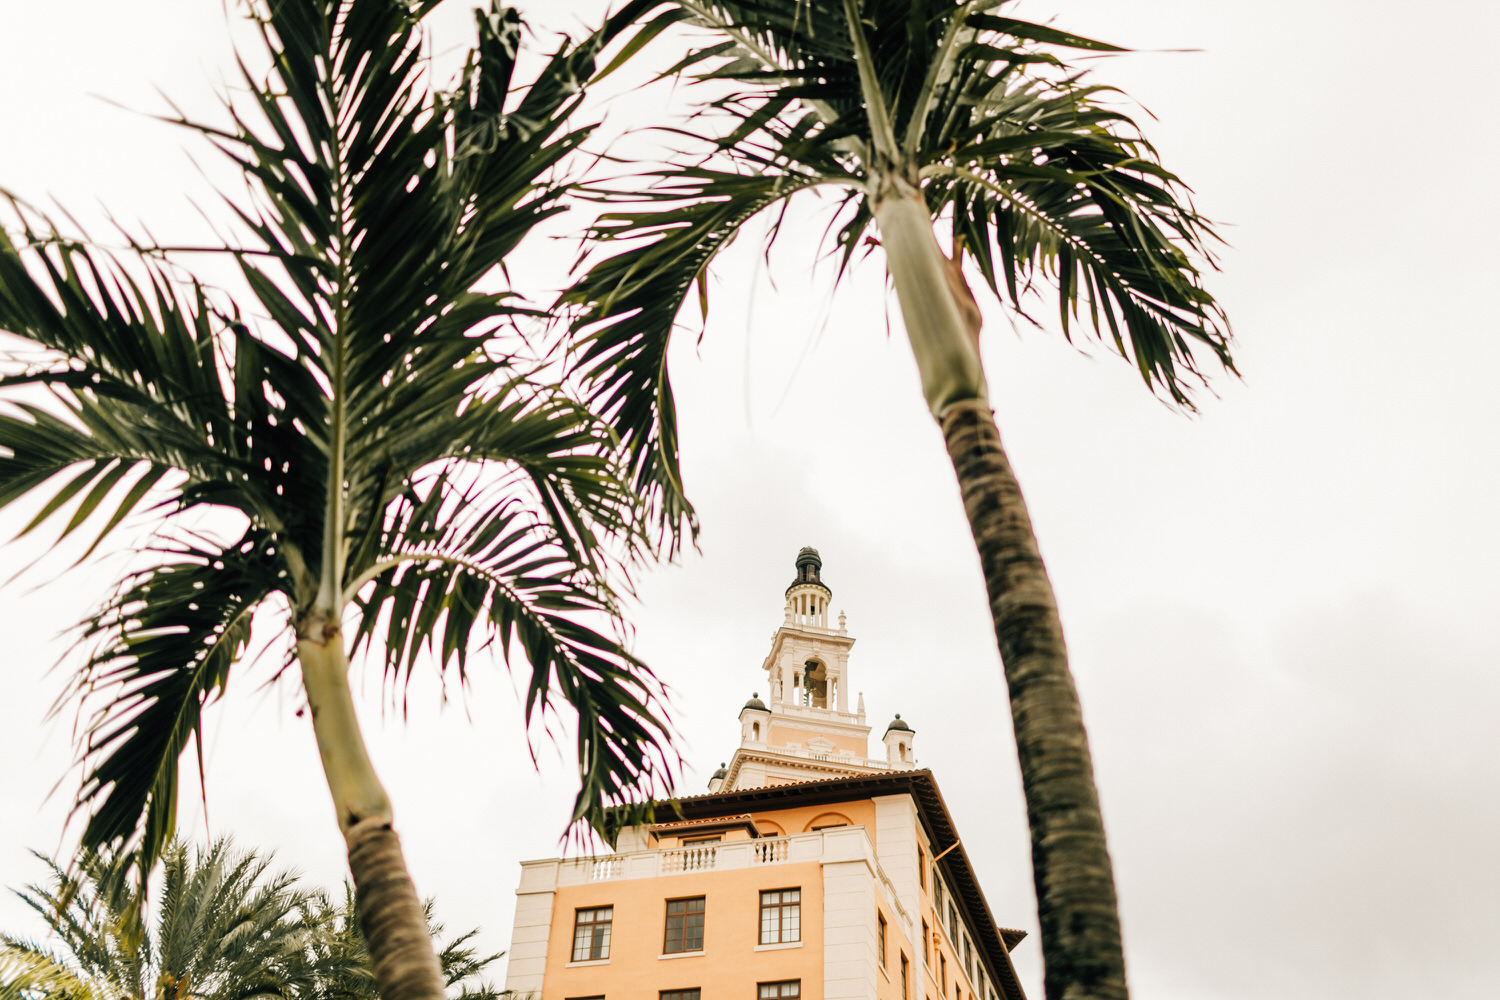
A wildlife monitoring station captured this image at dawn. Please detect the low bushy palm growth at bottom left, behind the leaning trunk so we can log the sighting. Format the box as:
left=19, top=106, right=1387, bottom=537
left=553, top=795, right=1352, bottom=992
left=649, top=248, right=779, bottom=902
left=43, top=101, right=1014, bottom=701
left=0, top=838, right=510, bottom=1000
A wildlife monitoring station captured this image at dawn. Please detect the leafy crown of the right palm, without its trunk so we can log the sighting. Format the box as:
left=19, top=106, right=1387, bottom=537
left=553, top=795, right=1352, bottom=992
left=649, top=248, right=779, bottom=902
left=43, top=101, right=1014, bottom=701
left=566, top=0, right=1232, bottom=520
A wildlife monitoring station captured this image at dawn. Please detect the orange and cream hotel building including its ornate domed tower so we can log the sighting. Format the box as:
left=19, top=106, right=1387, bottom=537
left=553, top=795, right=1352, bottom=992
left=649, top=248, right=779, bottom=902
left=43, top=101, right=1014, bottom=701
left=506, top=549, right=1025, bottom=1000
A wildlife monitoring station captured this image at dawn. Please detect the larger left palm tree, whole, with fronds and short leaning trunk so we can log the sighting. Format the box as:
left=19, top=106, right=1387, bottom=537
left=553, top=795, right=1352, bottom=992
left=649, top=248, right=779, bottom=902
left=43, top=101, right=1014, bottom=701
left=0, top=0, right=675, bottom=1000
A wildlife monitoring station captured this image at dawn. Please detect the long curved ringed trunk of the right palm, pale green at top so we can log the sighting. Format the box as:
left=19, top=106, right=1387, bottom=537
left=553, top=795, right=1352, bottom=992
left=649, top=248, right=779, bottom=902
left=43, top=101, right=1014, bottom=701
left=875, top=178, right=1128, bottom=1000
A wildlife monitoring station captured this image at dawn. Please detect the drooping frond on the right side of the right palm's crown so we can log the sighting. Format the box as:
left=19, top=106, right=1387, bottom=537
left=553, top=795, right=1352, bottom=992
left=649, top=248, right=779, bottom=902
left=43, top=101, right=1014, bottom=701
left=923, top=57, right=1233, bottom=405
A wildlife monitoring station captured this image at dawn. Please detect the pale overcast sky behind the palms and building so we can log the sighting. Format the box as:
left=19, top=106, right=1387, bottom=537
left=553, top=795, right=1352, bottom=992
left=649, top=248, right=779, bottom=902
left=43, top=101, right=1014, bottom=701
left=0, top=0, right=1500, bottom=1000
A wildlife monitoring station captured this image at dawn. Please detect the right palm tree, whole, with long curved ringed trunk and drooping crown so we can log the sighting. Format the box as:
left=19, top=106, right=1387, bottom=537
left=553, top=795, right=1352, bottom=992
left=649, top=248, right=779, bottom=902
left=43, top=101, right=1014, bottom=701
left=566, top=0, right=1232, bottom=999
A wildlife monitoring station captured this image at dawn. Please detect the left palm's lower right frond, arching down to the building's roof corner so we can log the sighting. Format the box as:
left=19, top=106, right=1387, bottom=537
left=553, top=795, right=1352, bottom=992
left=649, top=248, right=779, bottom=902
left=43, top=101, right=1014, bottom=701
left=354, top=474, right=677, bottom=823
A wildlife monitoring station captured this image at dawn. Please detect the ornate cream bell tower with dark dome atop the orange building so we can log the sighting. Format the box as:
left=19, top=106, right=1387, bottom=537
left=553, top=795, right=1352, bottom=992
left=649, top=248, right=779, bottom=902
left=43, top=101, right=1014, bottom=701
left=713, top=546, right=917, bottom=792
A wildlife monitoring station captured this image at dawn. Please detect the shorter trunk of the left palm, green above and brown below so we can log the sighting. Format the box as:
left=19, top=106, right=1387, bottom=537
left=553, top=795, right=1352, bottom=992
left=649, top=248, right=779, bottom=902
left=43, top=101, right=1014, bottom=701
left=297, top=629, right=444, bottom=1000
